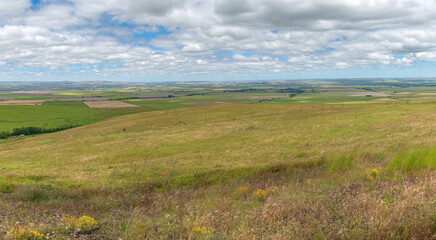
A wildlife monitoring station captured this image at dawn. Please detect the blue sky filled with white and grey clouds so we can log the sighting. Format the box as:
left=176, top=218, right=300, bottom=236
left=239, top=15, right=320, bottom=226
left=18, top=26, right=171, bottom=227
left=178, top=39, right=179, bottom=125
left=0, top=0, right=436, bottom=82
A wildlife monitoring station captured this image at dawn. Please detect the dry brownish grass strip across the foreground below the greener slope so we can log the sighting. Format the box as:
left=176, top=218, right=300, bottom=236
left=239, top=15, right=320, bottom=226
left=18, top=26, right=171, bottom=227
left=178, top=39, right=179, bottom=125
left=0, top=170, right=436, bottom=239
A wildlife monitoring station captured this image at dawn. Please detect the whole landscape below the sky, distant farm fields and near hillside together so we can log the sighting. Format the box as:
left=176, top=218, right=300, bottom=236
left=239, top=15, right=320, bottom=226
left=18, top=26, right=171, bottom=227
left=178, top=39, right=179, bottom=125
left=0, top=79, right=436, bottom=239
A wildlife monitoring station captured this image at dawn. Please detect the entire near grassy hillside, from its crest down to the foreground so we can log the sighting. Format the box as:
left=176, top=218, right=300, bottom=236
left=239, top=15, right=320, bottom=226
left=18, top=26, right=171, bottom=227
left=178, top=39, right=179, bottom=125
left=0, top=103, right=436, bottom=239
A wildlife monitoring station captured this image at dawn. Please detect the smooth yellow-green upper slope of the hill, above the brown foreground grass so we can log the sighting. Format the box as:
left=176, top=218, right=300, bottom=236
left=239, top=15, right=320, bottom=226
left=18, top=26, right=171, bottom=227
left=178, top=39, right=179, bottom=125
left=0, top=101, right=434, bottom=188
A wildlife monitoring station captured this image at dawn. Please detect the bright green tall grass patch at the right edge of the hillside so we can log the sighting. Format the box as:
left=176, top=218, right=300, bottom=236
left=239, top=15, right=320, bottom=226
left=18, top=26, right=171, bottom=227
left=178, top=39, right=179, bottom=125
left=389, top=147, right=436, bottom=171
